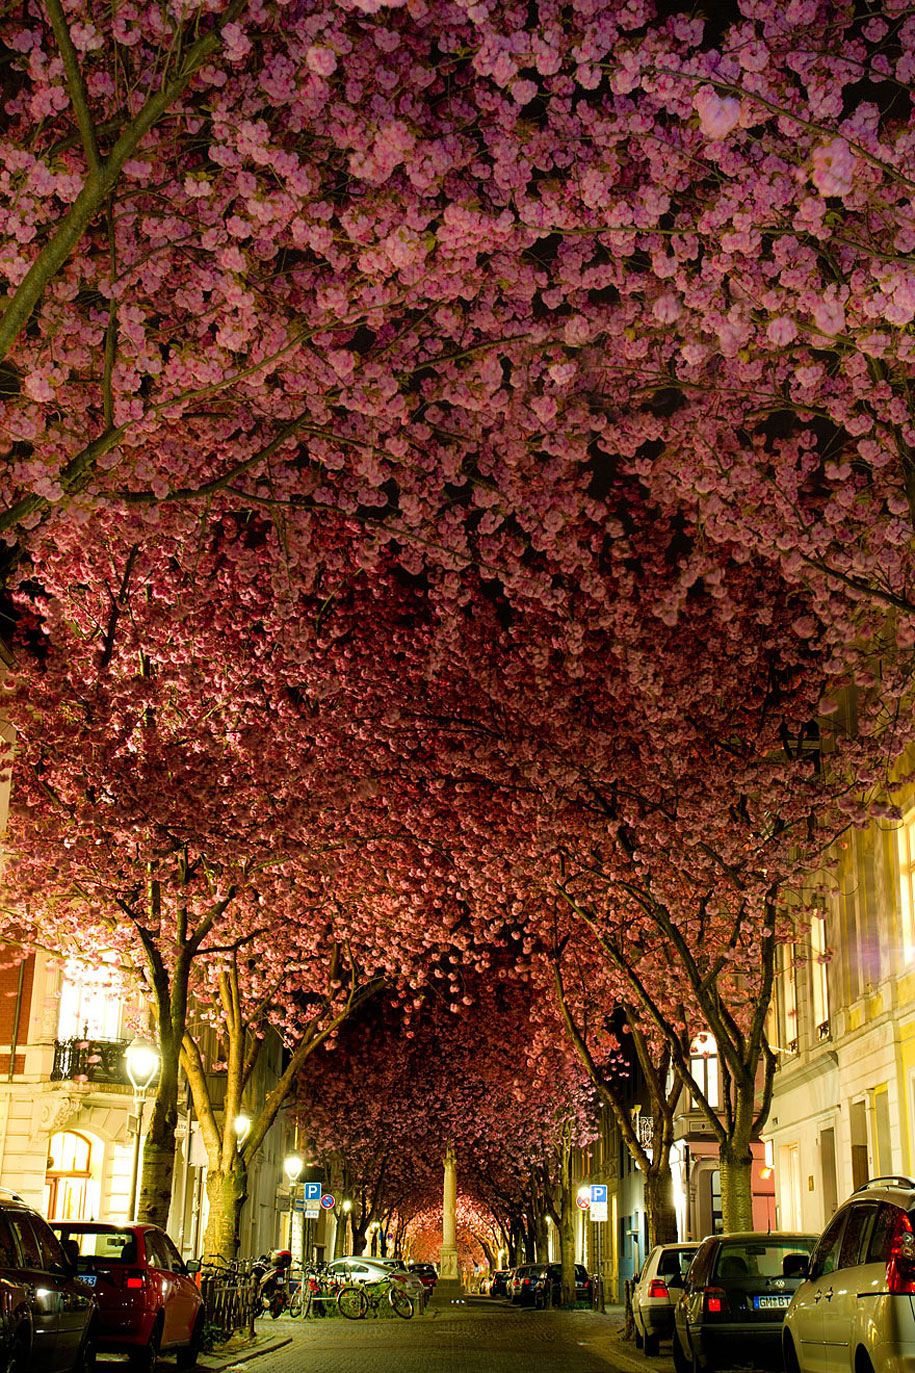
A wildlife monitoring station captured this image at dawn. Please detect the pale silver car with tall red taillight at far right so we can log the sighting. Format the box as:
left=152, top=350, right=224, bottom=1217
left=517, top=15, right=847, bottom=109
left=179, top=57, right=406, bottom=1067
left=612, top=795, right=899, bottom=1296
left=782, top=1177, right=915, bottom=1373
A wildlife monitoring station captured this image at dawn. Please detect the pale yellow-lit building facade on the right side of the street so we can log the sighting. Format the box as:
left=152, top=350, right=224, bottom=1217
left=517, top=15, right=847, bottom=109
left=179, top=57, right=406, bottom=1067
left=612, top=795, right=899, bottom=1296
left=767, top=806, right=915, bottom=1230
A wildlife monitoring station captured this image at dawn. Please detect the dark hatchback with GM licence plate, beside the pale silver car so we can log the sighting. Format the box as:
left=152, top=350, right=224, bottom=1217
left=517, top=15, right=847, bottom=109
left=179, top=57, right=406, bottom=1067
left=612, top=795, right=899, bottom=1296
left=673, top=1230, right=816, bottom=1373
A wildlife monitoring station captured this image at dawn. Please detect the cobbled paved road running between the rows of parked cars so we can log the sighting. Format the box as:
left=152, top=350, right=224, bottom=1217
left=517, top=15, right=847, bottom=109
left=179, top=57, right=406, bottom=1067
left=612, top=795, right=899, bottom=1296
left=193, top=1303, right=634, bottom=1373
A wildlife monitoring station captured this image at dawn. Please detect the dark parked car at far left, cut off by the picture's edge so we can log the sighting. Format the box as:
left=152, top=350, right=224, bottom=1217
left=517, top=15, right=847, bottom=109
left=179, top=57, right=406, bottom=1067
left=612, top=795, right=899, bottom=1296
left=0, top=1196, right=98, bottom=1373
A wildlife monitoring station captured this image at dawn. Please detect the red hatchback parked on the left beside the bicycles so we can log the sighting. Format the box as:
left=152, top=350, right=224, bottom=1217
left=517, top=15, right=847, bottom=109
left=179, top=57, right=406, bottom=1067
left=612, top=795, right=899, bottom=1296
left=52, top=1221, right=203, bottom=1370
